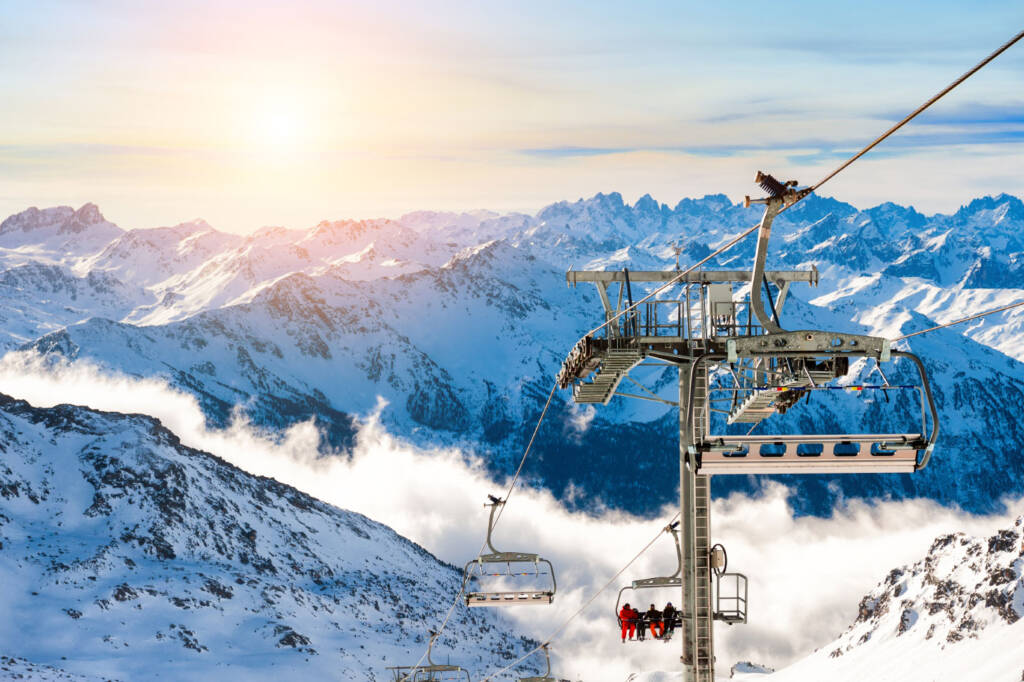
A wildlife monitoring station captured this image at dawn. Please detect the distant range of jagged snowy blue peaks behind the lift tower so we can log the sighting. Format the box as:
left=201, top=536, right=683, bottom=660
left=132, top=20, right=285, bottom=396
left=0, top=194, right=1024, bottom=511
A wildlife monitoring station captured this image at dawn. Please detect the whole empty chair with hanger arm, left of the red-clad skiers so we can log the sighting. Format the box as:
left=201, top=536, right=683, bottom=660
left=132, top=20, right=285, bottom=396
left=463, top=495, right=556, bottom=606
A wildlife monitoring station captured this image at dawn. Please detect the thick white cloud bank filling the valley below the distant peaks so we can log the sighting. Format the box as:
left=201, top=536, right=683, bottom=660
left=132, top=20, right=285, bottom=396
left=0, top=352, right=1024, bottom=680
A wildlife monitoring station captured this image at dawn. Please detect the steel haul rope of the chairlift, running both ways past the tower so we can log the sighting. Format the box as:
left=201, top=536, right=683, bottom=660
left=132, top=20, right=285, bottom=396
left=395, top=23, right=1024, bottom=682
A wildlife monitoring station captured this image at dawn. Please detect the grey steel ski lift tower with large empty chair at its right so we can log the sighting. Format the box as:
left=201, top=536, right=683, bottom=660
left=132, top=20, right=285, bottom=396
left=558, top=173, right=938, bottom=682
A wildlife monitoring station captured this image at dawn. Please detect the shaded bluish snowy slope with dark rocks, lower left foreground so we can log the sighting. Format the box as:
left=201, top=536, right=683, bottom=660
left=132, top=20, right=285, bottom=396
left=0, top=395, right=535, bottom=680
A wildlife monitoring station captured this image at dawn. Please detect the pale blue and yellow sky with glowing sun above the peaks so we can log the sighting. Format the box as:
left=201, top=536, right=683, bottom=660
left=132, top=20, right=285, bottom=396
left=0, top=0, right=1024, bottom=232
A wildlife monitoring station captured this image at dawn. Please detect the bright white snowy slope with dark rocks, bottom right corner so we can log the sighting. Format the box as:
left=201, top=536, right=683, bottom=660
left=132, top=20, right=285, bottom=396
left=736, top=517, right=1024, bottom=682
